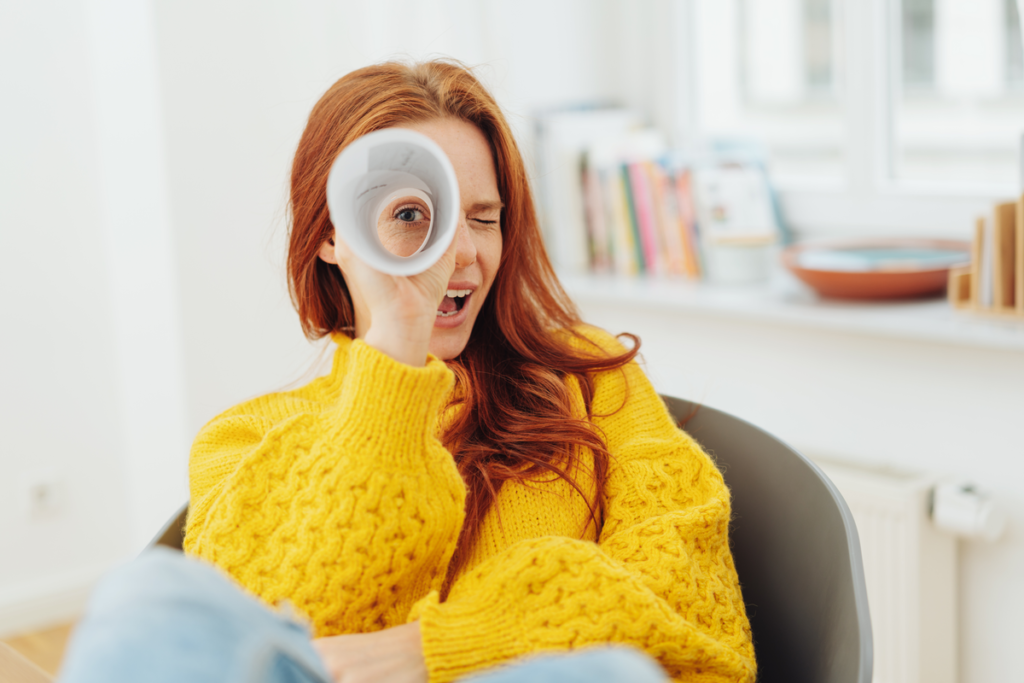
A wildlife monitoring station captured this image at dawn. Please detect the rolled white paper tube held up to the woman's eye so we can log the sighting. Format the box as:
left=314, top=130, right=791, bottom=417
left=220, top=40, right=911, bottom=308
left=327, top=128, right=460, bottom=275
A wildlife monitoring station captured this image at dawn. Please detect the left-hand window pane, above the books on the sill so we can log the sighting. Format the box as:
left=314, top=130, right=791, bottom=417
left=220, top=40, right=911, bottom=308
left=694, top=0, right=846, bottom=180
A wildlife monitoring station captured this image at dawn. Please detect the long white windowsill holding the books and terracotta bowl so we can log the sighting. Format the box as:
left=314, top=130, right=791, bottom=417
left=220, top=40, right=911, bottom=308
left=560, top=272, right=1024, bottom=352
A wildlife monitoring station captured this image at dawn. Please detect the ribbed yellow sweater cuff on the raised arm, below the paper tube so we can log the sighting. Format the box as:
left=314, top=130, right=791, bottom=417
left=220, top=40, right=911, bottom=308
left=337, top=340, right=455, bottom=462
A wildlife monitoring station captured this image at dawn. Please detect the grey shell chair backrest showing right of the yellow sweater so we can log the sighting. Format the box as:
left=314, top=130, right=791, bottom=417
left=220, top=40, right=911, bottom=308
left=662, top=396, right=872, bottom=683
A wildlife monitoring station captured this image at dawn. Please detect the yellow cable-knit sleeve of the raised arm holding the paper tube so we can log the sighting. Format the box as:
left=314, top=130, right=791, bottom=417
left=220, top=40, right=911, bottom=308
left=185, top=341, right=465, bottom=635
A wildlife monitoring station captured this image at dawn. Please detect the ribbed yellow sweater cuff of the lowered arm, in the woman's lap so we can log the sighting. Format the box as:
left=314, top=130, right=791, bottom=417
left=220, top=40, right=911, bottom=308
left=411, top=593, right=530, bottom=683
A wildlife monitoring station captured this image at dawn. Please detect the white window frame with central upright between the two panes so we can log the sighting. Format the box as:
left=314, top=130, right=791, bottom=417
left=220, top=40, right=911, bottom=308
left=671, top=0, right=1024, bottom=238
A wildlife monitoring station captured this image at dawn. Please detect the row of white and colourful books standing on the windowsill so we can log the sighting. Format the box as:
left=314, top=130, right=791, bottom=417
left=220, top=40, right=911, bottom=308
left=535, top=108, right=784, bottom=282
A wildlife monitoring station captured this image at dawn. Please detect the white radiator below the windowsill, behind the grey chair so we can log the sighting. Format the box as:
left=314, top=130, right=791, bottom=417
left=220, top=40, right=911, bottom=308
left=815, top=459, right=957, bottom=683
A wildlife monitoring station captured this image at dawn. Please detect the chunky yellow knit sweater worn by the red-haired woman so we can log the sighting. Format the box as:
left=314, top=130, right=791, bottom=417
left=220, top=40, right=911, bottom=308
left=185, top=328, right=755, bottom=682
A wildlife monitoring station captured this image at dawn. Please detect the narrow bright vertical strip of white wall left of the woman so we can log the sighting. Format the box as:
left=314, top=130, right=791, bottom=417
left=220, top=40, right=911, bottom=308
left=85, top=0, right=191, bottom=549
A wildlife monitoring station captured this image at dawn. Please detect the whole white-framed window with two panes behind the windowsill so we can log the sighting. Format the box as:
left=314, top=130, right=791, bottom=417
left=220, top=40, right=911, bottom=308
left=678, top=0, right=1024, bottom=236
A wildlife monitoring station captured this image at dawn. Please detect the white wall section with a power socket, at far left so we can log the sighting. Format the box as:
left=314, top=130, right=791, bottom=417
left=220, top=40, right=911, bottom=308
left=0, top=0, right=130, bottom=632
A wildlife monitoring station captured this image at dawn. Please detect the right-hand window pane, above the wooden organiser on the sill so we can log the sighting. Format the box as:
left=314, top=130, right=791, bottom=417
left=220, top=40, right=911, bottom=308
left=890, top=0, right=1024, bottom=187
